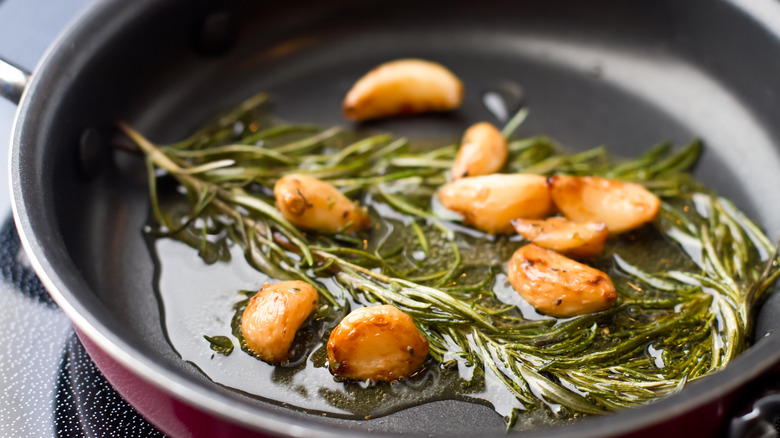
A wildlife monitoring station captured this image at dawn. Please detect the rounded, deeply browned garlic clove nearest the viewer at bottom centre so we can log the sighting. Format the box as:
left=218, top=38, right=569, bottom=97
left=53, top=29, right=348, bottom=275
left=328, top=305, right=428, bottom=381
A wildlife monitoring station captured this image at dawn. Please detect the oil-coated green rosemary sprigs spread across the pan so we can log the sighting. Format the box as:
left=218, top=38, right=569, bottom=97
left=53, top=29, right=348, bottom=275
left=120, top=96, right=780, bottom=424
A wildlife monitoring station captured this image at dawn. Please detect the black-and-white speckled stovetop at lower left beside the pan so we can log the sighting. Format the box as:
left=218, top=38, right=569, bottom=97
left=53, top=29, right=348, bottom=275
left=0, top=219, right=163, bottom=437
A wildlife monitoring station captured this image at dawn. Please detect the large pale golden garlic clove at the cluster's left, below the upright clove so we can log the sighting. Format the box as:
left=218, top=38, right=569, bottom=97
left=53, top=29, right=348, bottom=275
left=438, top=174, right=553, bottom=233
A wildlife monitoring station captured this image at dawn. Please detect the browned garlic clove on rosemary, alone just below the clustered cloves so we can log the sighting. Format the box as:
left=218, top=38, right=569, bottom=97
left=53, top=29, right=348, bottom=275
left=507, top=244, right=617, bottom=317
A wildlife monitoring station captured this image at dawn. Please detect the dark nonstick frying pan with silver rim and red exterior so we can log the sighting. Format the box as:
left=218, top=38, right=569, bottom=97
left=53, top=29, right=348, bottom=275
left=4, top=0, right=780, bottom=436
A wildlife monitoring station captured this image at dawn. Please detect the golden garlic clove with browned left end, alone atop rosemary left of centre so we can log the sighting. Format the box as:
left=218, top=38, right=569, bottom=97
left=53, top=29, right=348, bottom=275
left=274, top=174, right=369, bottom=233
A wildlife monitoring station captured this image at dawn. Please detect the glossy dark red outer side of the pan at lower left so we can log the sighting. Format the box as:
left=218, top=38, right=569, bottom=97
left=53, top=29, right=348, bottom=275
left=74, top=326, right=271, bottom=438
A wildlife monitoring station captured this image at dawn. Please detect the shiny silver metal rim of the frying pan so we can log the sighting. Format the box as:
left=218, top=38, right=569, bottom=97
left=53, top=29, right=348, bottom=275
left=9, top=0, right=780, bottom=437
